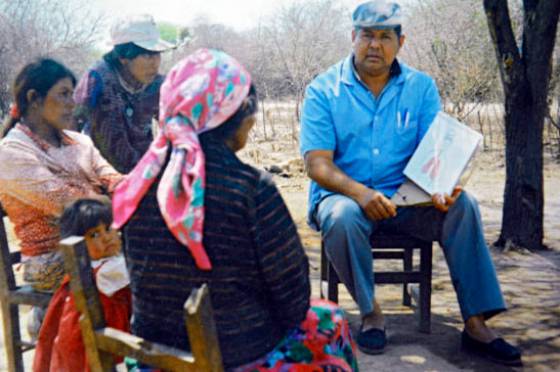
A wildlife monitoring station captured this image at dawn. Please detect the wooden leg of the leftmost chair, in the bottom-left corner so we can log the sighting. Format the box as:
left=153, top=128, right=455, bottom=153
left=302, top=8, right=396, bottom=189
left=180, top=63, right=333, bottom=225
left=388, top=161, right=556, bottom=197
left=2, top=301, right=24, bottom=372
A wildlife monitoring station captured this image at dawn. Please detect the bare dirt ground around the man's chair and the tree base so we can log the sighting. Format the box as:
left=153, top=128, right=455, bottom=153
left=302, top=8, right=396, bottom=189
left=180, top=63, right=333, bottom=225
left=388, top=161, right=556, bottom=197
left=0, top=138, right=560, bottom=372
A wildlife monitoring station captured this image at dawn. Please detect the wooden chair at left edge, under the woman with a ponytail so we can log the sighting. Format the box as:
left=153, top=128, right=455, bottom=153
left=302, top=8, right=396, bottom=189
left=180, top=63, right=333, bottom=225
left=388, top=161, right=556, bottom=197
left=0, top=206, right=51, bottom=372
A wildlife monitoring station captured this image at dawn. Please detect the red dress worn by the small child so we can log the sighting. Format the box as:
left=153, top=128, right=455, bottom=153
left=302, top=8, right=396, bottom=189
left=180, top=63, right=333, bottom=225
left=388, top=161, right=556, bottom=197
left=33, top=268, right=132, bottom=372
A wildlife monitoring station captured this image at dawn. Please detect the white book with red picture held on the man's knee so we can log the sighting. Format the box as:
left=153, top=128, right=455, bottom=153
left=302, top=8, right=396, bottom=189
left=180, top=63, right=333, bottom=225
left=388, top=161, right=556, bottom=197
left=391, top=111, right=482, bottom=205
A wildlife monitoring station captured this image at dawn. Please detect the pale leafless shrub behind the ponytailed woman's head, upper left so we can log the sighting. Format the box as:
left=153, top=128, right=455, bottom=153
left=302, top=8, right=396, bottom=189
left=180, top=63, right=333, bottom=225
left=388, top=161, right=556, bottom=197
left=0, top=0, right=102, bottom=113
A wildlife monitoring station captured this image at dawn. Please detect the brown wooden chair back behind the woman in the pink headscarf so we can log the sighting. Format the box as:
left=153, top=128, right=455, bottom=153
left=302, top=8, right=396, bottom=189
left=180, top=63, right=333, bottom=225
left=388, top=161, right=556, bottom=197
left=60, top=237, right=223, bottom=372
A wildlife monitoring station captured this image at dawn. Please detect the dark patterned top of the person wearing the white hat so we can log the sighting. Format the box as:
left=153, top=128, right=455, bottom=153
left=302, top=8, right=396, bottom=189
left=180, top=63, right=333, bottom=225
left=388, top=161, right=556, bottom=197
left=74, top=61, right=163, bottom=174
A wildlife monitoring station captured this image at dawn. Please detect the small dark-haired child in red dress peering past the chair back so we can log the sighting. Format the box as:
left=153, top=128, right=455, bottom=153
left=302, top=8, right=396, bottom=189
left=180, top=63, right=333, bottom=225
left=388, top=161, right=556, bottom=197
left=33, top=199, right=132, bottom=372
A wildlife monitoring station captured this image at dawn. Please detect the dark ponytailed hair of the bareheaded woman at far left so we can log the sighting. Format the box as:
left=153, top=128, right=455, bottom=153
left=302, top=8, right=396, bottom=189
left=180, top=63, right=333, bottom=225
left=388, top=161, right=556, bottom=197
left=0, top=58, right=76, bottom=138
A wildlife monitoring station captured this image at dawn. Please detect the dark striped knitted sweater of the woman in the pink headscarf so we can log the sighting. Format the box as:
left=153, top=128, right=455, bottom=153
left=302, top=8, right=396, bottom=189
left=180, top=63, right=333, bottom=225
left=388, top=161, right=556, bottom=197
left=125, top=136, right=310, bottom=368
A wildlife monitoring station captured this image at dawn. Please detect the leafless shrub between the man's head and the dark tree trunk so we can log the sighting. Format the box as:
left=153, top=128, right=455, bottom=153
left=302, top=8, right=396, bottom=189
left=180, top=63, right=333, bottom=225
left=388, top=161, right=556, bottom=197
left=403, top=0, right=501, bottom=119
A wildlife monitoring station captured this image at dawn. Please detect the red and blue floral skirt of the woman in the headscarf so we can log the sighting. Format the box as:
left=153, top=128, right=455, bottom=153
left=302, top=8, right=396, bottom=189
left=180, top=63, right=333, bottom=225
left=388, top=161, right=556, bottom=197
left=235, top=300, right=358, bottom=372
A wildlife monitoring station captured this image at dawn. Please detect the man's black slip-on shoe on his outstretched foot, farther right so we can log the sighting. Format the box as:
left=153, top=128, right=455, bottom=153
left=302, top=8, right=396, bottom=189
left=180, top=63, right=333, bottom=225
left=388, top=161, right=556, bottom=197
left=461, top=331, right=523, bottom=367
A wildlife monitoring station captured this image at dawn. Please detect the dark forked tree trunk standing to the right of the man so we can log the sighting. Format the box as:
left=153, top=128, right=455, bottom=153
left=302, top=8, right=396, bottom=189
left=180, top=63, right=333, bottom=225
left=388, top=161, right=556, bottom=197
left=484, top=0, right=560, bottom=250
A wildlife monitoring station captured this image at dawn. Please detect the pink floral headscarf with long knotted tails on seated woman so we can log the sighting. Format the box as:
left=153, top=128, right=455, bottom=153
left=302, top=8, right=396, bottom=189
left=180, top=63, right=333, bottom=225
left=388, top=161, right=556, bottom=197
left=113, top=49, right=251, bottom=270
